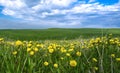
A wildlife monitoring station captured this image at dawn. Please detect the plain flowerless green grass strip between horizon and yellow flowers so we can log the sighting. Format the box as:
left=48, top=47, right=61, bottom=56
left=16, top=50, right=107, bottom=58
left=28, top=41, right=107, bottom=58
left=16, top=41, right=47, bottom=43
left=0, top=28, right=120, bottom=40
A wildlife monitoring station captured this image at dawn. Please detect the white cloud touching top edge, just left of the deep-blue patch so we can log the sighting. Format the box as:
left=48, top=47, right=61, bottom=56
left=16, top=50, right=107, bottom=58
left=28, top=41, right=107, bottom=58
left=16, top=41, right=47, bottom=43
left=32, top=0, right=77, bottom=10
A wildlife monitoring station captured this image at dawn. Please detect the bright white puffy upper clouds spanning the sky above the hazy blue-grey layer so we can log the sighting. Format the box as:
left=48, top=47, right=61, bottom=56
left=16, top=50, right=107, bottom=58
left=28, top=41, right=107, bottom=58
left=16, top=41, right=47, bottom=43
left=0, top=0, right=120, bottom=18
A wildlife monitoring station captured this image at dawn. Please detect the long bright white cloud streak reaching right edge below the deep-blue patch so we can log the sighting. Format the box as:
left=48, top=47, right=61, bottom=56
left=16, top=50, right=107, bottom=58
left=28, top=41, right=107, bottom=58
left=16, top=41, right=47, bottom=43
left=42, top=3, right=120, bottom=17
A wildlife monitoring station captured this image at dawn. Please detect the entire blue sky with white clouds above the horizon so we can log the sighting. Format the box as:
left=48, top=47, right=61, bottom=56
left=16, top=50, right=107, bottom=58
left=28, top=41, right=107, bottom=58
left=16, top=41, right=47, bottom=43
left=0, top=0, right=120, bottom=29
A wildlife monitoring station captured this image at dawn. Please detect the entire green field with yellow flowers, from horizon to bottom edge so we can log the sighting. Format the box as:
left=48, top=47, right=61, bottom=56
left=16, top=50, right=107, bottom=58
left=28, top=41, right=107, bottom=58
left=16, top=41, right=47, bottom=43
left=0, top=28, right=120, bottom=73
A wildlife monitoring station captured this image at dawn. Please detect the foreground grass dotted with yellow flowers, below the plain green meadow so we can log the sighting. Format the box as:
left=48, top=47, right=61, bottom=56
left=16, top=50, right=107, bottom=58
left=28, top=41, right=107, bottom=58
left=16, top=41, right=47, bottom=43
left=0, top=34, right=120, bottom=73
